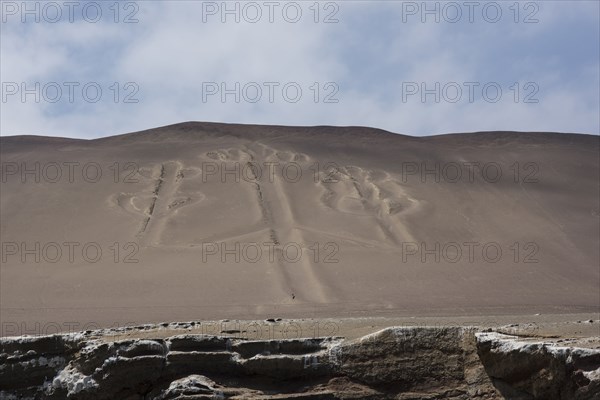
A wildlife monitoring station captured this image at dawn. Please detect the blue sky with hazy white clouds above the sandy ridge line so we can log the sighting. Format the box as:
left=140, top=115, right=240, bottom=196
left=0, top=0, right=600, bottom=138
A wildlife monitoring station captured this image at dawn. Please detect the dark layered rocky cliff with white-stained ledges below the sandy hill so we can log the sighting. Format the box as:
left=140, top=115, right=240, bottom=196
left=0, top=327, right=600, bottom=400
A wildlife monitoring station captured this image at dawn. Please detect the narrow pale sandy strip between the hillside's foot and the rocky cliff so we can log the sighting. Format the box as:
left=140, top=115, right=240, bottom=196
left=81, top=314, right=600, bottom=349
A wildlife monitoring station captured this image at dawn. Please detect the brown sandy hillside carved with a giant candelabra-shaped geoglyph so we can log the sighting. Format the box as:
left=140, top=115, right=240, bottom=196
left=0, top=122, right=600, bottom=336
